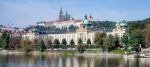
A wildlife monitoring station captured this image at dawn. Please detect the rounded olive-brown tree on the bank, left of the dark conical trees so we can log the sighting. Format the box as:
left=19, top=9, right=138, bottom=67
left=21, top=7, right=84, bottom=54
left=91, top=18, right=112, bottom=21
left=21, top=39, right=32, bottom=52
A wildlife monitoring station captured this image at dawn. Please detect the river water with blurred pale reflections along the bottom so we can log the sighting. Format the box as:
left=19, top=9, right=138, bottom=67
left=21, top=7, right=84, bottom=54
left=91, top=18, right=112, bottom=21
left=0, top=55, right=150, bottom=67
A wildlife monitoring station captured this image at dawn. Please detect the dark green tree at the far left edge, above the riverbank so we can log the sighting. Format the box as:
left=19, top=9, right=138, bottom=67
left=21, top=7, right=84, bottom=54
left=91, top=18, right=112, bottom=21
left=1, top=31, right=10, bottom=49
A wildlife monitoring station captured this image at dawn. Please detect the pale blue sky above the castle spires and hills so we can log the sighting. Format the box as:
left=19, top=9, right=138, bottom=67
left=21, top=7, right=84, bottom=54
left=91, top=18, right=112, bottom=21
left=0, top=0, right=150, bottom=27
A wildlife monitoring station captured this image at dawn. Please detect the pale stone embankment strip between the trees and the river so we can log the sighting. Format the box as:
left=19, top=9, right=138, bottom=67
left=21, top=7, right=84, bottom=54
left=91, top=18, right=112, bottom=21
left=0, top=49, right=121, bottom=56
